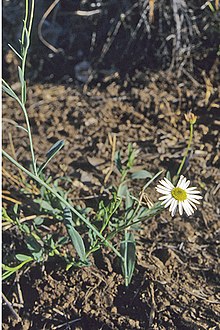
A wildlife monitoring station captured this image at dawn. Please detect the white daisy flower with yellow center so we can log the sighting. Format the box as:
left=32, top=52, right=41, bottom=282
left=156, top=175, right=202, bottom=217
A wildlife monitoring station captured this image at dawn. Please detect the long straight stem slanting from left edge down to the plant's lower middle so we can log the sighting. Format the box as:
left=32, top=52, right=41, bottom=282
left=2, top=150, right=124, bottom=260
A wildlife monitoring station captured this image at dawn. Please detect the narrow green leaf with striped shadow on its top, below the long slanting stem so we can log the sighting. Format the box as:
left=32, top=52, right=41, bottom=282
left=63, top=207, right=86, bottom=261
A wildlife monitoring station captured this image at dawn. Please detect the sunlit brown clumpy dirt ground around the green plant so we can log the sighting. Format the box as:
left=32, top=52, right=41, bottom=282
left=3, top=65, right=220, bottom=330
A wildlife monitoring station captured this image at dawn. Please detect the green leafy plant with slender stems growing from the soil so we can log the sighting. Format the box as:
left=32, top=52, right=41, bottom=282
left=3, top=0, right=201, bottom=286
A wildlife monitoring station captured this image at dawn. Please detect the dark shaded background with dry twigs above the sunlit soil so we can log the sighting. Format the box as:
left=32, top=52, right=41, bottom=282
left=3, top=0, right=220, bottom=83
